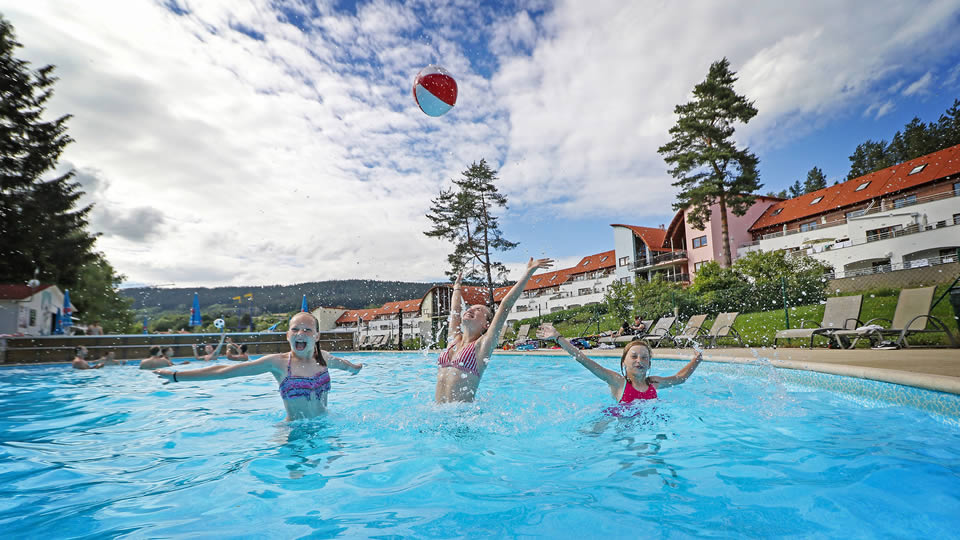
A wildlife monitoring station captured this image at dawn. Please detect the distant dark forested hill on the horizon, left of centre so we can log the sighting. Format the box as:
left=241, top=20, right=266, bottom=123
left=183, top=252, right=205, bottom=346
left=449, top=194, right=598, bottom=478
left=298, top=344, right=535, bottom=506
left=120, top=279, right=444, bottom=313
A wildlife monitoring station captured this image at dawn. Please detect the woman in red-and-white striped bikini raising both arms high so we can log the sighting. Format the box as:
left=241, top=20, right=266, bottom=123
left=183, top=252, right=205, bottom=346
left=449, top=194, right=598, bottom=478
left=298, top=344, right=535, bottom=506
left=434, top=257, right=553, bottom=403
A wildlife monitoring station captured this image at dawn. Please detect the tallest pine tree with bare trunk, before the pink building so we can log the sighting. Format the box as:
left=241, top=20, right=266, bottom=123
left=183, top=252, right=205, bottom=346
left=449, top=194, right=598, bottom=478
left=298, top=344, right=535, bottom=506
left=657, top=58, right=761, bottom=266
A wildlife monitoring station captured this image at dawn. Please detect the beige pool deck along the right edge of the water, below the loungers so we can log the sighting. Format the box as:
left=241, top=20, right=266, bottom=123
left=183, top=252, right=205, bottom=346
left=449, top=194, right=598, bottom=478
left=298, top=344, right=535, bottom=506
left=494, top=347, right=960, bottom=394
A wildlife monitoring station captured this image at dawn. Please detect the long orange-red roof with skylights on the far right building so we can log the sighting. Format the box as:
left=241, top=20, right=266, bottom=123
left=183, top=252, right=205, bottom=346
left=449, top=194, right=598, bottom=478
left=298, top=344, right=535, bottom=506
left=750, top=145, right=960, bottom=231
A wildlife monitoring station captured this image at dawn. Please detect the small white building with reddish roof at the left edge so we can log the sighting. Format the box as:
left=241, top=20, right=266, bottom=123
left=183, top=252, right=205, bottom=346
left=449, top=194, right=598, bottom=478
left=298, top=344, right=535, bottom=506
left=0, top=284, right=63, bottom=336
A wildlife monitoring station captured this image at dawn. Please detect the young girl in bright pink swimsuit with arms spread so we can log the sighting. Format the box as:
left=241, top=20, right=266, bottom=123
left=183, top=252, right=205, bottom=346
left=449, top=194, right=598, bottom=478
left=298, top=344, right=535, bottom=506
left=537, top=323, right=703, bottom=404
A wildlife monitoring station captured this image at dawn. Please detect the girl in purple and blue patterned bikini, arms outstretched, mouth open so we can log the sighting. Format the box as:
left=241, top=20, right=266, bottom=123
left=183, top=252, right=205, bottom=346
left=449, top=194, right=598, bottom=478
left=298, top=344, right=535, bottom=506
left=154, top=312, right=363, bottom=420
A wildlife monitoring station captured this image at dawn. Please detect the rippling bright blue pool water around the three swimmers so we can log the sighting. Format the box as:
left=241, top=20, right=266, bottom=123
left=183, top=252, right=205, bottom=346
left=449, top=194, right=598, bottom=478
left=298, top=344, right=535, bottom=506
left=0, top=353, right=960, bottom=538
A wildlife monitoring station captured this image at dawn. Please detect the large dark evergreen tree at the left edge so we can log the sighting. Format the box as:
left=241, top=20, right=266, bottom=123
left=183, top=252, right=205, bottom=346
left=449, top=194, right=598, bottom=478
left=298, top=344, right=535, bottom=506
left=0, top=16, right=95, bottom=287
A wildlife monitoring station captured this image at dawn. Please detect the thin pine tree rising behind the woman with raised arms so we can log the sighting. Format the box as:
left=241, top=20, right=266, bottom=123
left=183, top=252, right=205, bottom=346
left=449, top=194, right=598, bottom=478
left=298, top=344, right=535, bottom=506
left=424, top=159, right=517, bottom=305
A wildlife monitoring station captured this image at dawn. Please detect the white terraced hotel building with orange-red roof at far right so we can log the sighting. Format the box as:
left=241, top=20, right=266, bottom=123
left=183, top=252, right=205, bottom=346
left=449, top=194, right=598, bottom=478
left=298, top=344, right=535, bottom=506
left=739, top=145, right=960, bottom=278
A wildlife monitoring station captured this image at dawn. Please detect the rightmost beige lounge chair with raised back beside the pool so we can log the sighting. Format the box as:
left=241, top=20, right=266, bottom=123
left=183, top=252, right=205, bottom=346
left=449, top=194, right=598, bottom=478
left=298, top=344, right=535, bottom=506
left=834, top=287, right=957, bottom=349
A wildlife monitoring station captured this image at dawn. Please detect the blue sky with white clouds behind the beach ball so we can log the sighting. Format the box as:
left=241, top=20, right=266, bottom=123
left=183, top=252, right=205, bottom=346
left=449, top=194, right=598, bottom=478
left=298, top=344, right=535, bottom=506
left=0, top=0, right=960, bottom=286
